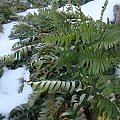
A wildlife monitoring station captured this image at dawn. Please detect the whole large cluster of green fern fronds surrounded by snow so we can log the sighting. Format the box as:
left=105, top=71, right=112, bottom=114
left=0, top=0, right=120, bottom=120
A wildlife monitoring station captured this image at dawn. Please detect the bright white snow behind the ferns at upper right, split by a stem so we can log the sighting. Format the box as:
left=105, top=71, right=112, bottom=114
left=58, top=0, right=120, bottom=22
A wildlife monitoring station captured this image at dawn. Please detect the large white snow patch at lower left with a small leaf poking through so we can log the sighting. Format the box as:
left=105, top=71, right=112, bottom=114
left=0, top=67, right=32, bottom=115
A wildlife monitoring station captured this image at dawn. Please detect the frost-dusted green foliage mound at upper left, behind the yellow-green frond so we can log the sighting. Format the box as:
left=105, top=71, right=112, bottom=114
left=9, top=8, right=78, bottom=40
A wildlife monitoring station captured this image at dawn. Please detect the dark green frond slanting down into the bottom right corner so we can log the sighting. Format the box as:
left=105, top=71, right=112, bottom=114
left=92, top=94, right=120, bottom=120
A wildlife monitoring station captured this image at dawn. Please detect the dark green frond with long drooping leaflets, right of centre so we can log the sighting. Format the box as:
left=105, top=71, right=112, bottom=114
left=79, top=49, right=116, bottom=74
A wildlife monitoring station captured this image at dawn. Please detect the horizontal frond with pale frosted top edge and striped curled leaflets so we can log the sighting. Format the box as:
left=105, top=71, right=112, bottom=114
left=29, top=80, right=80, bottom=94
